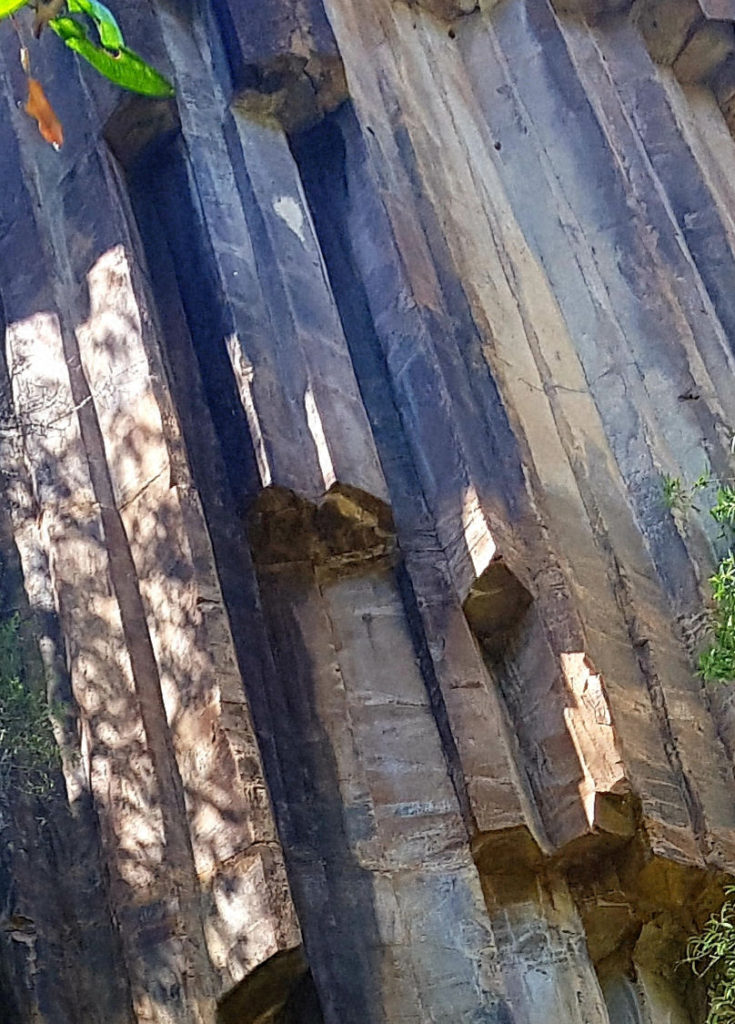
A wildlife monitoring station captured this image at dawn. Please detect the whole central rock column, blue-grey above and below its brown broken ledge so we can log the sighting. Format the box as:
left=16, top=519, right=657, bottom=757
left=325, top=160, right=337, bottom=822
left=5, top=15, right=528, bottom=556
left=149, top=5, right=536, bottom=1024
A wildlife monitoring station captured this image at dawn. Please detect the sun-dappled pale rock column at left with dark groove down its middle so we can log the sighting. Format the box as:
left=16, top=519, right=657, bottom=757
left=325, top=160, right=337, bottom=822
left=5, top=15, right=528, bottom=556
left=0, top=12, right=300, bottom=1024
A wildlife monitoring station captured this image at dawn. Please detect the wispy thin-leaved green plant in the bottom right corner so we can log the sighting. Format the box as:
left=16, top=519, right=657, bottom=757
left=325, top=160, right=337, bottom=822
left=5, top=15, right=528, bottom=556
left=683, top=886, right=735, bottom=1024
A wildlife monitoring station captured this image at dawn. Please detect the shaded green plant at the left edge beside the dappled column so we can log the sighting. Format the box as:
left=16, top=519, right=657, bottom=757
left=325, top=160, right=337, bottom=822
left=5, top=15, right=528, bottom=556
left=0, top=614, right=58, bottom=796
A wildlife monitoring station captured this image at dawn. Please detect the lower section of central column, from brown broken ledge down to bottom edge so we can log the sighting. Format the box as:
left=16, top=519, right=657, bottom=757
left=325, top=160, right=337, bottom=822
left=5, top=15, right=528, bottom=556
left=252, top=489, right=510, bottom=1024
